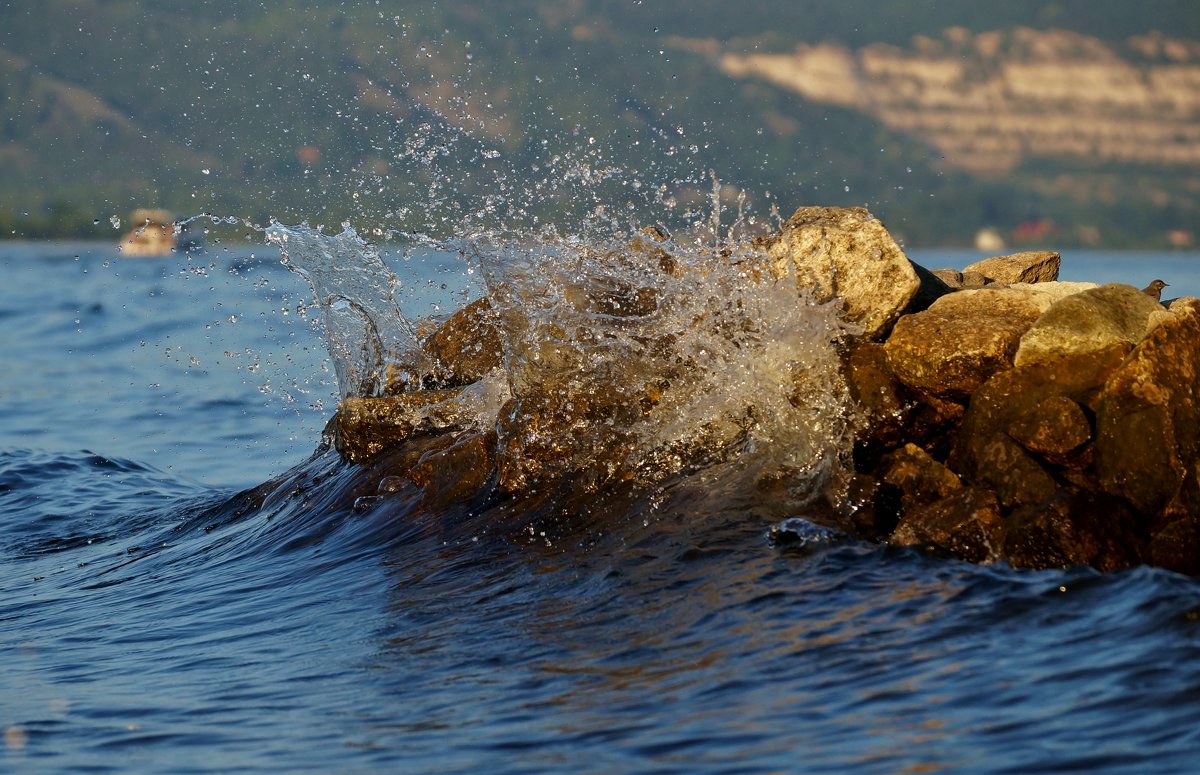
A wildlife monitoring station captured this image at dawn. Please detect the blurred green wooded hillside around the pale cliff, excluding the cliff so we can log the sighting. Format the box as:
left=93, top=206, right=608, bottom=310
left=0, top=0, right=1200, bottom=245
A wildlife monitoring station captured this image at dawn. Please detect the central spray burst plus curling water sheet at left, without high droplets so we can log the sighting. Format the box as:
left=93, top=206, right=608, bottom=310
left=269, top=217, right=854, bottom=523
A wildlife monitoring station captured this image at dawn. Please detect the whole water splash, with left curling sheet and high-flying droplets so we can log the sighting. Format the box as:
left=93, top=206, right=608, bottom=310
left=211, top=97, right=854, bottom=509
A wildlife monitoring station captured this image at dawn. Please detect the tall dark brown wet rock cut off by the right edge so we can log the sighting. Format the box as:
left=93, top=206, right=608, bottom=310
left=1096, top=301, right=1200, bottom=515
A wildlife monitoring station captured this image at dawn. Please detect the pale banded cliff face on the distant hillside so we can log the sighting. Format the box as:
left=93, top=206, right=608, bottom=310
left=719, top=28, right=1200, bottom=173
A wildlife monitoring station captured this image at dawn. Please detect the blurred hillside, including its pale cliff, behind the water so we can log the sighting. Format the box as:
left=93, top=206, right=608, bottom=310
left=0, top=0, right=1200, bottom=247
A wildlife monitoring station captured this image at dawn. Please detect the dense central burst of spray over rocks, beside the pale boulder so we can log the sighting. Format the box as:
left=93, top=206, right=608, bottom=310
left=469, top=227, right=854, bottom=507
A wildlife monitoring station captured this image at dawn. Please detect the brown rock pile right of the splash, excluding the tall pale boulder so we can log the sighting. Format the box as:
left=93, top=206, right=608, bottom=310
left=846, top=233, right=1200, bottom=575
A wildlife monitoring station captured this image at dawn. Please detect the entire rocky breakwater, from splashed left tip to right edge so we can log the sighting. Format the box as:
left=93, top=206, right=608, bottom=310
left=331, top=208, right=1200, bottom=575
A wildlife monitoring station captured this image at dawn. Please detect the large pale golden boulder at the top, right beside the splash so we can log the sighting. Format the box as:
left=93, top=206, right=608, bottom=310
left=766, top=208, right=920, bottom=337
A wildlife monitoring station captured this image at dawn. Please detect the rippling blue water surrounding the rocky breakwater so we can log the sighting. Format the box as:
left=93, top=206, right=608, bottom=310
left=0, top=234, right=1200, bottom=773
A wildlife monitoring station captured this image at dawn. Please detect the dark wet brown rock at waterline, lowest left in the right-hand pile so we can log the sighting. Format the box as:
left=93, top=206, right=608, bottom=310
left=890, top=487, right=1004, bottom=563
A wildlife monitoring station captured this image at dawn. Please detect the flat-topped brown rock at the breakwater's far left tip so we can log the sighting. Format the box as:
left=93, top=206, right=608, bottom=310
left=334, top=390, right=470, bottom=463
